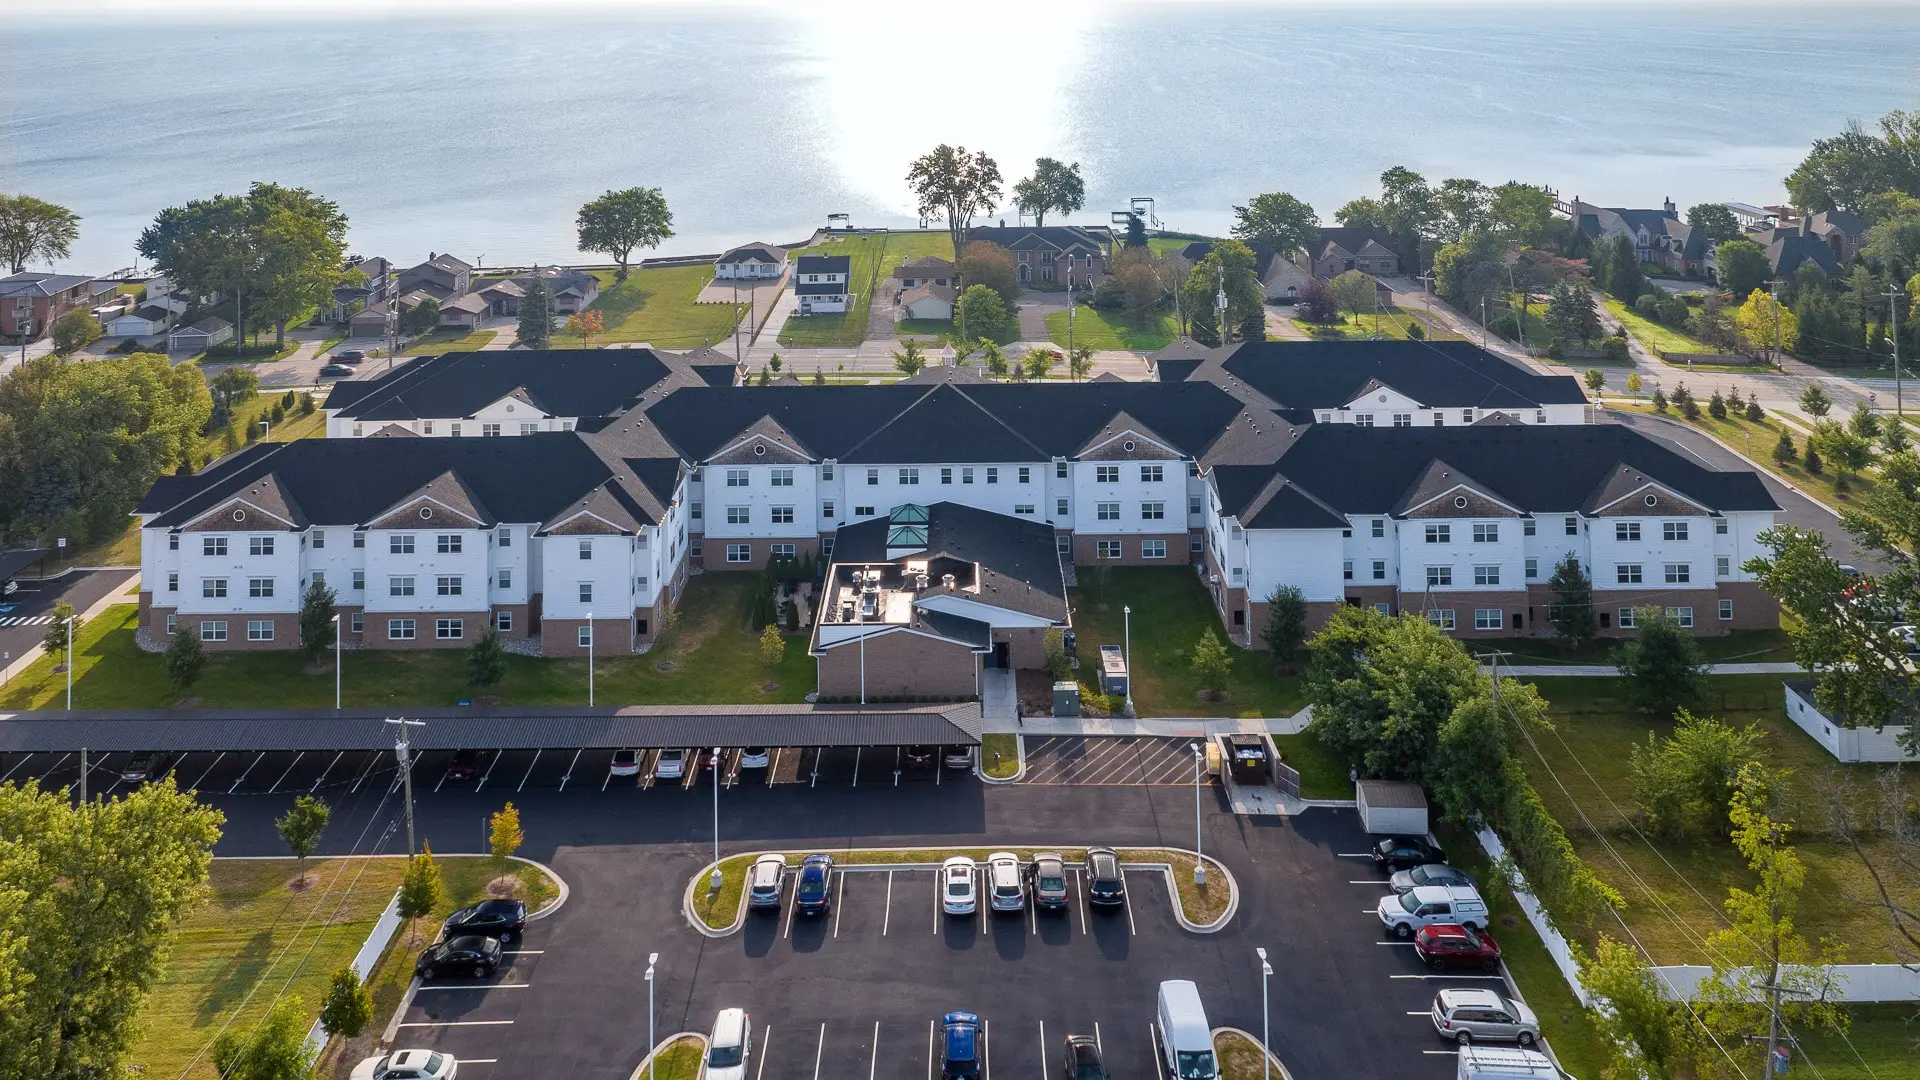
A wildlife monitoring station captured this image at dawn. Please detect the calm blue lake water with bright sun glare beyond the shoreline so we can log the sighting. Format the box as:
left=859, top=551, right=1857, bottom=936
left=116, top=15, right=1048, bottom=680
left=0, top=0, right=1920, bottom=273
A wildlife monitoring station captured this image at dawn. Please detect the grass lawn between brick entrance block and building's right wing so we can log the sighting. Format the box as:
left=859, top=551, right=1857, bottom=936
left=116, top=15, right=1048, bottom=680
left=1068, top=567, right=1306, bottom=717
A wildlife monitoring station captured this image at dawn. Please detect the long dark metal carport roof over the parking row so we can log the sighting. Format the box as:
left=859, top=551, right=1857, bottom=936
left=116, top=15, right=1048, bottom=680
left=0, top=703, right=981, bottom=751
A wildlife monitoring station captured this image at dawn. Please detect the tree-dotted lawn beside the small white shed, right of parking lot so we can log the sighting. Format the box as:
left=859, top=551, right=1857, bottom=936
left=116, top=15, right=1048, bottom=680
left=1523, top=675, right=1920, bottom=963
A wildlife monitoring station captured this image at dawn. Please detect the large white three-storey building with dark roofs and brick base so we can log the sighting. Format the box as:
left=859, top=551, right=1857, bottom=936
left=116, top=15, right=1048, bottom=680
left=136, top=342, right=1778, bottom=664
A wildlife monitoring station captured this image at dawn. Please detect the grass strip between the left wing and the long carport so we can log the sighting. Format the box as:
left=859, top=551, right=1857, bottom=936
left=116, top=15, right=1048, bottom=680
left=0, top=573, right=814, bottom=709
